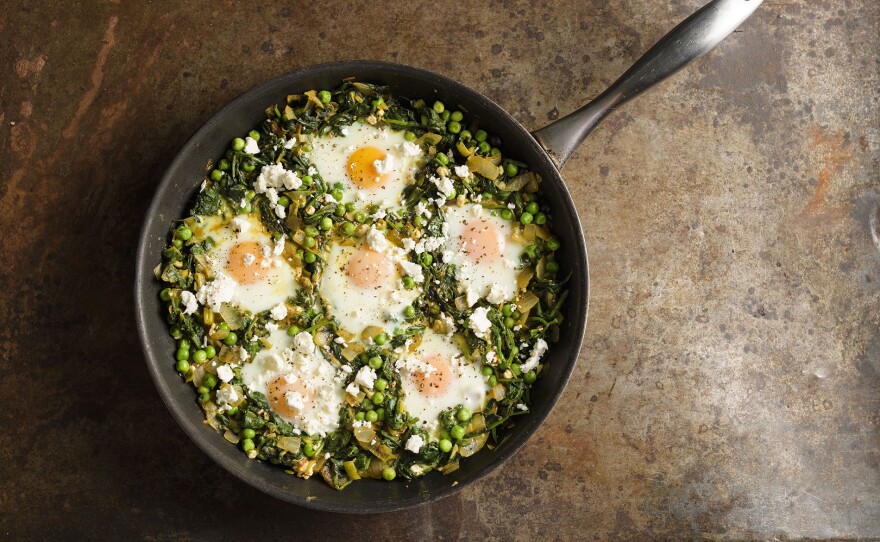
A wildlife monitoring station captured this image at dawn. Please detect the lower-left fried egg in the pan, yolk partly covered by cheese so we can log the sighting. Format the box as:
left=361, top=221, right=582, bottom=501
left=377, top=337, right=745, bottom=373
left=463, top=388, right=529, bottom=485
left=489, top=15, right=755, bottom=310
left=241, top=330, right=345, bottom=435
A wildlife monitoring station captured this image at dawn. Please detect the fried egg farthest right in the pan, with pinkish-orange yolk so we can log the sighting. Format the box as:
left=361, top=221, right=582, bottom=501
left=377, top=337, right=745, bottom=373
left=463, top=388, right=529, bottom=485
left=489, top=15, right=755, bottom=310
left=443, top=204, right=525, bottom=305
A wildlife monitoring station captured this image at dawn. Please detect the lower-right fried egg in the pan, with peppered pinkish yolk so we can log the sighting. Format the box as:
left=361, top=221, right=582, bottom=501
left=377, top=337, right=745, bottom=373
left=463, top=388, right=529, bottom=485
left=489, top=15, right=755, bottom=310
left=397, top=329, right=488, bottom=440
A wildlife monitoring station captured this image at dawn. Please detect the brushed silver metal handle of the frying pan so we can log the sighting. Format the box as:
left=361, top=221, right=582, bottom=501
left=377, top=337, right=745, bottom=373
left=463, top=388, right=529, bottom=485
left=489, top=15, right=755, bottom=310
left=532, top=0, right=763, bottom=168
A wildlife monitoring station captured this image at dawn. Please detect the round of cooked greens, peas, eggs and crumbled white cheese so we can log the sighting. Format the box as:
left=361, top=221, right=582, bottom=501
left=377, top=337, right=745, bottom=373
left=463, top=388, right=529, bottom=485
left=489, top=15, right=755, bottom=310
left=156, top=81, right=567, bottom=489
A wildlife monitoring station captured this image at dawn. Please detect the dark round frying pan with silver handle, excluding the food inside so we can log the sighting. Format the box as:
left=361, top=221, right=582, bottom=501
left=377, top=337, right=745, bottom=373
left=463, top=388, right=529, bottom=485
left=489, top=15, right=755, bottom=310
left=135, top=0, right=761, bottom=513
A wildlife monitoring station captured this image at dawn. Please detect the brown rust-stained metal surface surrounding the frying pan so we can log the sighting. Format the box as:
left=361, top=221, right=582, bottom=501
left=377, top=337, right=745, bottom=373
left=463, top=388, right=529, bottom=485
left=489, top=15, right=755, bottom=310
left=0, top=0, right=880, bottom=540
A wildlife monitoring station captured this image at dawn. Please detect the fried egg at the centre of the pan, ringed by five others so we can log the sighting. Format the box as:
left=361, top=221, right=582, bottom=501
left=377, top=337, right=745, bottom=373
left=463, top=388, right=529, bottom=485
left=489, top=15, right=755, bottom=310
left=318, top=228, right=419, bottom=335
